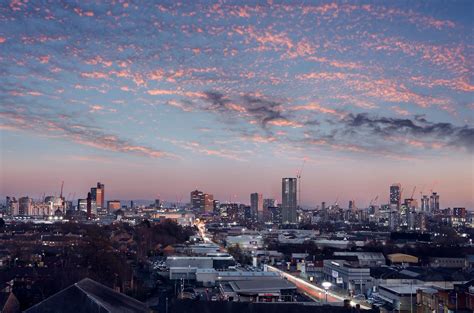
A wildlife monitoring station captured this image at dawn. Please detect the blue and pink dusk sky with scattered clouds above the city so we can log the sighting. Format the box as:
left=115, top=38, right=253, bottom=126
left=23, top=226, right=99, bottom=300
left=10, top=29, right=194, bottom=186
left=0, top=0, right=474, bottom=208
